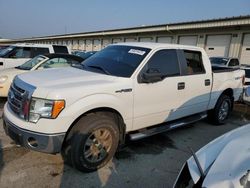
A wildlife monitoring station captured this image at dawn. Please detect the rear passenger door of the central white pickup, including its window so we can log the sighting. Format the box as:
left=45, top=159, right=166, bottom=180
left=178, top=50, right=212, bottom=116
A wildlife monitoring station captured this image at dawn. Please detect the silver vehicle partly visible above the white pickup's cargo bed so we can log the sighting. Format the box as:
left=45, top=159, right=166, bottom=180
left=209, top=57, right=240, bottom=68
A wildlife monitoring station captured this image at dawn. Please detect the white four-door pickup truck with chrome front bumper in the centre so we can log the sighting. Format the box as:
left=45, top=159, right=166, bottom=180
left=3, top=43, right=245, bottom=171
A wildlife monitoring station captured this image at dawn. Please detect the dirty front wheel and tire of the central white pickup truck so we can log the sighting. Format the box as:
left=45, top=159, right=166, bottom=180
left=62, top=112, right=119, bottom=172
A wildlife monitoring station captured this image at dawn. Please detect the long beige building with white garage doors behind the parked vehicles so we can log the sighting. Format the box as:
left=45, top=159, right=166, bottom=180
left=3, top=16, right=250, bottom=64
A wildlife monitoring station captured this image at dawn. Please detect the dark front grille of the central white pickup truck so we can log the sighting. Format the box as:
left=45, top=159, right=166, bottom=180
left=8, top=82, right=29, bottom=120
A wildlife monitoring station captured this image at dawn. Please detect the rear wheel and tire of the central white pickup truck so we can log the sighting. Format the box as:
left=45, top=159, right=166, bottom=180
left=208, top=95, right=233, bottom=125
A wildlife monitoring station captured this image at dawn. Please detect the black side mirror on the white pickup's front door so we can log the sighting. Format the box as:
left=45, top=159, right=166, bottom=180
left=138, top=68, right=163, bottom=83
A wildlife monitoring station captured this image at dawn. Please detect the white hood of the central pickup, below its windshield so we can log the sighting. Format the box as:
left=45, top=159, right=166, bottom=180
left=18, top=67, right=120, bottom=98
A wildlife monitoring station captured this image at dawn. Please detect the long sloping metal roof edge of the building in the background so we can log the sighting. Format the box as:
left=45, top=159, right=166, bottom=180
left=7, top=15, right=250, bottom=41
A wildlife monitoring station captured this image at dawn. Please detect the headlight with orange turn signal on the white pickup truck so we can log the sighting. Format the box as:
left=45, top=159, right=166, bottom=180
left=29, top=98, right=65, bottom=123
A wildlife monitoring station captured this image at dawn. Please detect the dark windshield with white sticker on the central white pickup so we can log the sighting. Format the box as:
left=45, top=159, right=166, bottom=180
left=82, top=45, right=150, bottom=78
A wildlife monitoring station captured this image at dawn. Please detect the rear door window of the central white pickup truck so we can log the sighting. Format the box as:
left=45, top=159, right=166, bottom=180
left=184, top=50, right=205, bottom=75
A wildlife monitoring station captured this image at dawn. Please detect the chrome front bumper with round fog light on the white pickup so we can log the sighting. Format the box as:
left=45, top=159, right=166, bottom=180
left=3, top=115, right=65, bottom=154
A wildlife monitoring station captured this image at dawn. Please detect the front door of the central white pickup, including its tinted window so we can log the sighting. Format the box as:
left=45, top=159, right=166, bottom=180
left=133, top=49, right=185, bottom=130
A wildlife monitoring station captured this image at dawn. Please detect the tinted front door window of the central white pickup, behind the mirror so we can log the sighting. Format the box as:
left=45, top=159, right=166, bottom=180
left=144, top=50, right=180, bottom=76
